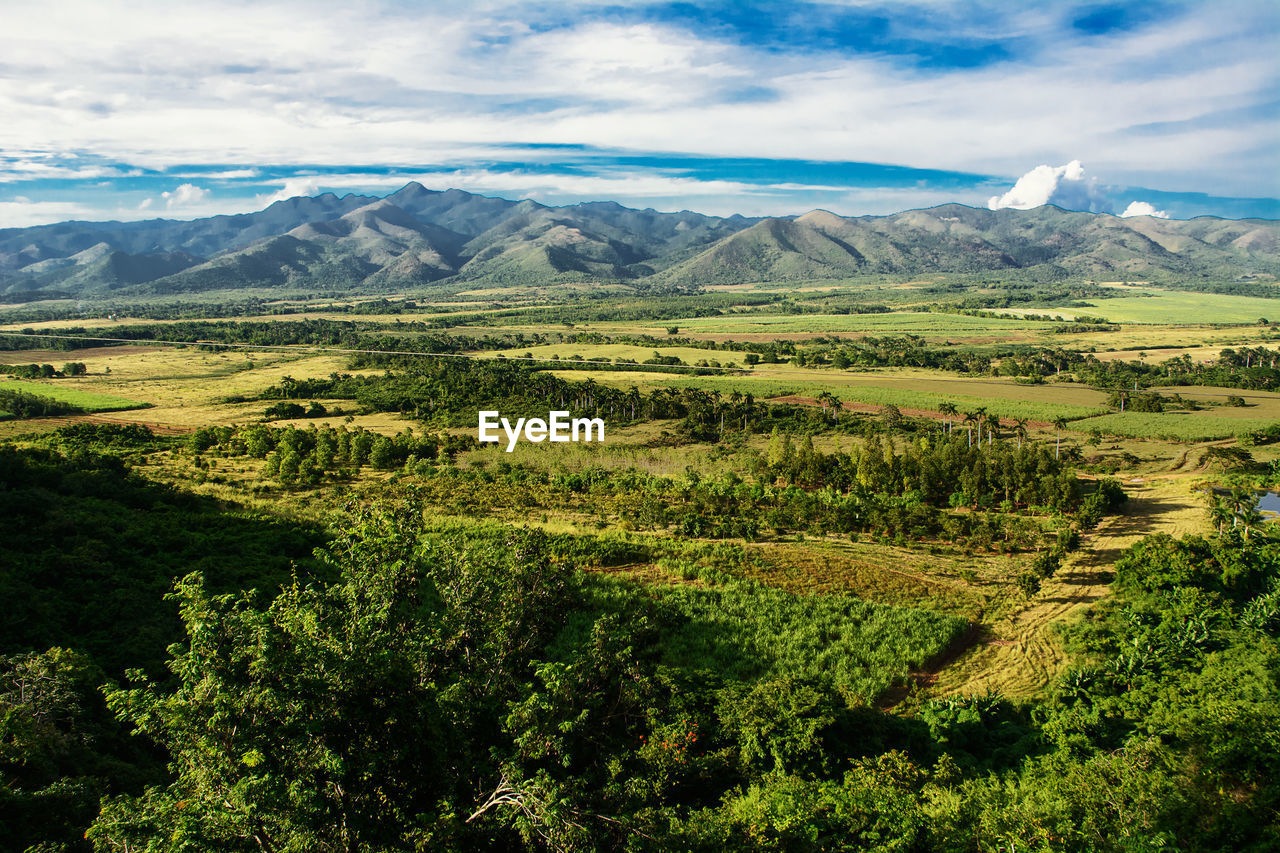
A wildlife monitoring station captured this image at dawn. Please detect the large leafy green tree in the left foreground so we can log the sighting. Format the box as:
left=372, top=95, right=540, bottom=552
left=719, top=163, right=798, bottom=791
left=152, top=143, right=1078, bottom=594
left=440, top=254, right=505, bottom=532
left=96, top=498, right=576, bottom=852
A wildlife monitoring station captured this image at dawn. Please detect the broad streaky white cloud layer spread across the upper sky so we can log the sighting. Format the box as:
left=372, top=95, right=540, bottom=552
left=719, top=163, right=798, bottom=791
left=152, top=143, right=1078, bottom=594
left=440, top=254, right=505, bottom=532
left=0, top=0, right=1280, bottom=204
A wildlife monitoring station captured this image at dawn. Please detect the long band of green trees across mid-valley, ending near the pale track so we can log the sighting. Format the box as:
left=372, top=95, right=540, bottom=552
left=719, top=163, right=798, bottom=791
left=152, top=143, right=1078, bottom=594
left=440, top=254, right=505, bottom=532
left=337, top=437, right=1125, bottom=548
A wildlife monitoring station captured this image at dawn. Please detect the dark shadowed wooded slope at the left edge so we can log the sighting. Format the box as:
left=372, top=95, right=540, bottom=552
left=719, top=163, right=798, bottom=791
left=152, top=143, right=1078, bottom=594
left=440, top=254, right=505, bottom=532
left=0, top=440, right=325, bottom=676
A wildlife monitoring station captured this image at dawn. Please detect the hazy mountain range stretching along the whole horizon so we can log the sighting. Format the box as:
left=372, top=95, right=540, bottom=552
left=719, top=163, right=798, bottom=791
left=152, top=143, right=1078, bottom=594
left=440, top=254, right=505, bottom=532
left=0, top=183, right=1280, bottom=302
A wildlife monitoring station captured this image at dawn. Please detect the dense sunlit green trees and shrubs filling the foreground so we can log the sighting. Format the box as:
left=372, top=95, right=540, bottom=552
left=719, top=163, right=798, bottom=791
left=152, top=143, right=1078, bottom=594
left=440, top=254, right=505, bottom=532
left=4, top=481, right=1280, bottom=850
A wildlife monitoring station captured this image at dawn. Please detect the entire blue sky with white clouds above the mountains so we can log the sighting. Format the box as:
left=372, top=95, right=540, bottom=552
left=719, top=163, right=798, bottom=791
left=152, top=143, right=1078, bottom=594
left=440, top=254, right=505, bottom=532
left=0, top=0, right=1280, bottom=228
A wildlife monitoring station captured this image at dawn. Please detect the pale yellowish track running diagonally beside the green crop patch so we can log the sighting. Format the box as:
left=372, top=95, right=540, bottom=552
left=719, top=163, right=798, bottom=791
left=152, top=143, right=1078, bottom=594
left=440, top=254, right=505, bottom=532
left=915, top=478, right=1206, bottom=695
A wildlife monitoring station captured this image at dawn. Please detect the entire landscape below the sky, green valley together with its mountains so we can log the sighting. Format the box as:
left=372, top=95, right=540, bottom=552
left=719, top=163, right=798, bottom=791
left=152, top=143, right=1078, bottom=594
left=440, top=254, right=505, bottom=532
left=0, top=186, right=1280, bottom=849
